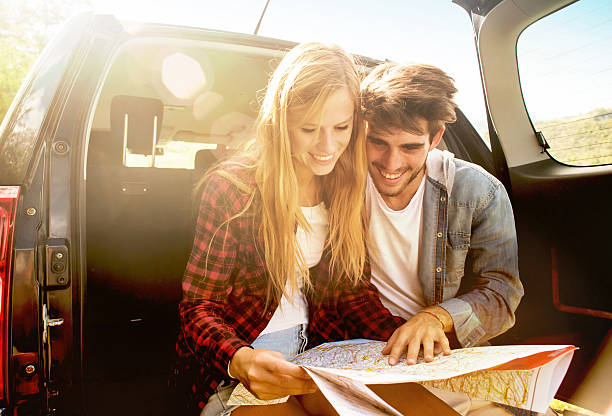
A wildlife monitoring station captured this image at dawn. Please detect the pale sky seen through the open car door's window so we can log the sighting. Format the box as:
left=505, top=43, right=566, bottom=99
left=517, top=0, right=612, bottom=119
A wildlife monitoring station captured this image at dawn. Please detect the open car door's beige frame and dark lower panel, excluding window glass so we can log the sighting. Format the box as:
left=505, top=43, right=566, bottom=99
left=464, top=0, right=612, bottom=408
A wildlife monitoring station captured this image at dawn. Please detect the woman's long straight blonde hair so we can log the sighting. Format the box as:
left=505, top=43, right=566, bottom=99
left=201, top=43, right=366, bottom=305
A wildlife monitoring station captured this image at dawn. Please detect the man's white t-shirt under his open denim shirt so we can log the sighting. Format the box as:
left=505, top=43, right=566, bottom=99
left=366, top=175, right=426, bottom=319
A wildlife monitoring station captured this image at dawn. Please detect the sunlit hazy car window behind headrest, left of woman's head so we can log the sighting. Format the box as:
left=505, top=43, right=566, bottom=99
left=88, top=39, right=279, bottom=170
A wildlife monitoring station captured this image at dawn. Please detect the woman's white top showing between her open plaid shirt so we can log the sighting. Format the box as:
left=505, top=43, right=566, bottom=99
left=261, top=203, right=329, bottom=334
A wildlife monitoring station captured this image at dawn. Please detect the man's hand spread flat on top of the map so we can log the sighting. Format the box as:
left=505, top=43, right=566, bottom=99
left=382, top=306, right=453, bottom=365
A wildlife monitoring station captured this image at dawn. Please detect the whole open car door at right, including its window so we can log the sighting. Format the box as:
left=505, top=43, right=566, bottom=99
left=454, top=0, right=612, bottom=414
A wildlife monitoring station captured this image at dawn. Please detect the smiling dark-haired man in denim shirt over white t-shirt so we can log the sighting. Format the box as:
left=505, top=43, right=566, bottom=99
left=361, top=63, right=523, bottom=364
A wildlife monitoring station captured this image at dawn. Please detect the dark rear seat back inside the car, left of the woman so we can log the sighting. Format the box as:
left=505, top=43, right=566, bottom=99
left=84, top=96, right=201, bottom=414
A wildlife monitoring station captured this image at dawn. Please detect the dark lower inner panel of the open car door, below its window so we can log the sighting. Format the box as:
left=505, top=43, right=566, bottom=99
left=499, top=160, right=612, bottom=401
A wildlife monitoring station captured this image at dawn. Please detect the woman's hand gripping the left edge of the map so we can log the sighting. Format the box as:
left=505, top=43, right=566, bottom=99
left=229, top=347, right=318, bottom=400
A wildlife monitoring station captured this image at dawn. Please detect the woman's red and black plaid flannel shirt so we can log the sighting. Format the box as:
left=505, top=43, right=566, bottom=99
left=174, top=168, right=404, bottom=408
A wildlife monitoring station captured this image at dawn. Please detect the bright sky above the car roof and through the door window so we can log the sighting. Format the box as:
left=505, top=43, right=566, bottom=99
left=34, top=0, right=612, bottom=134
